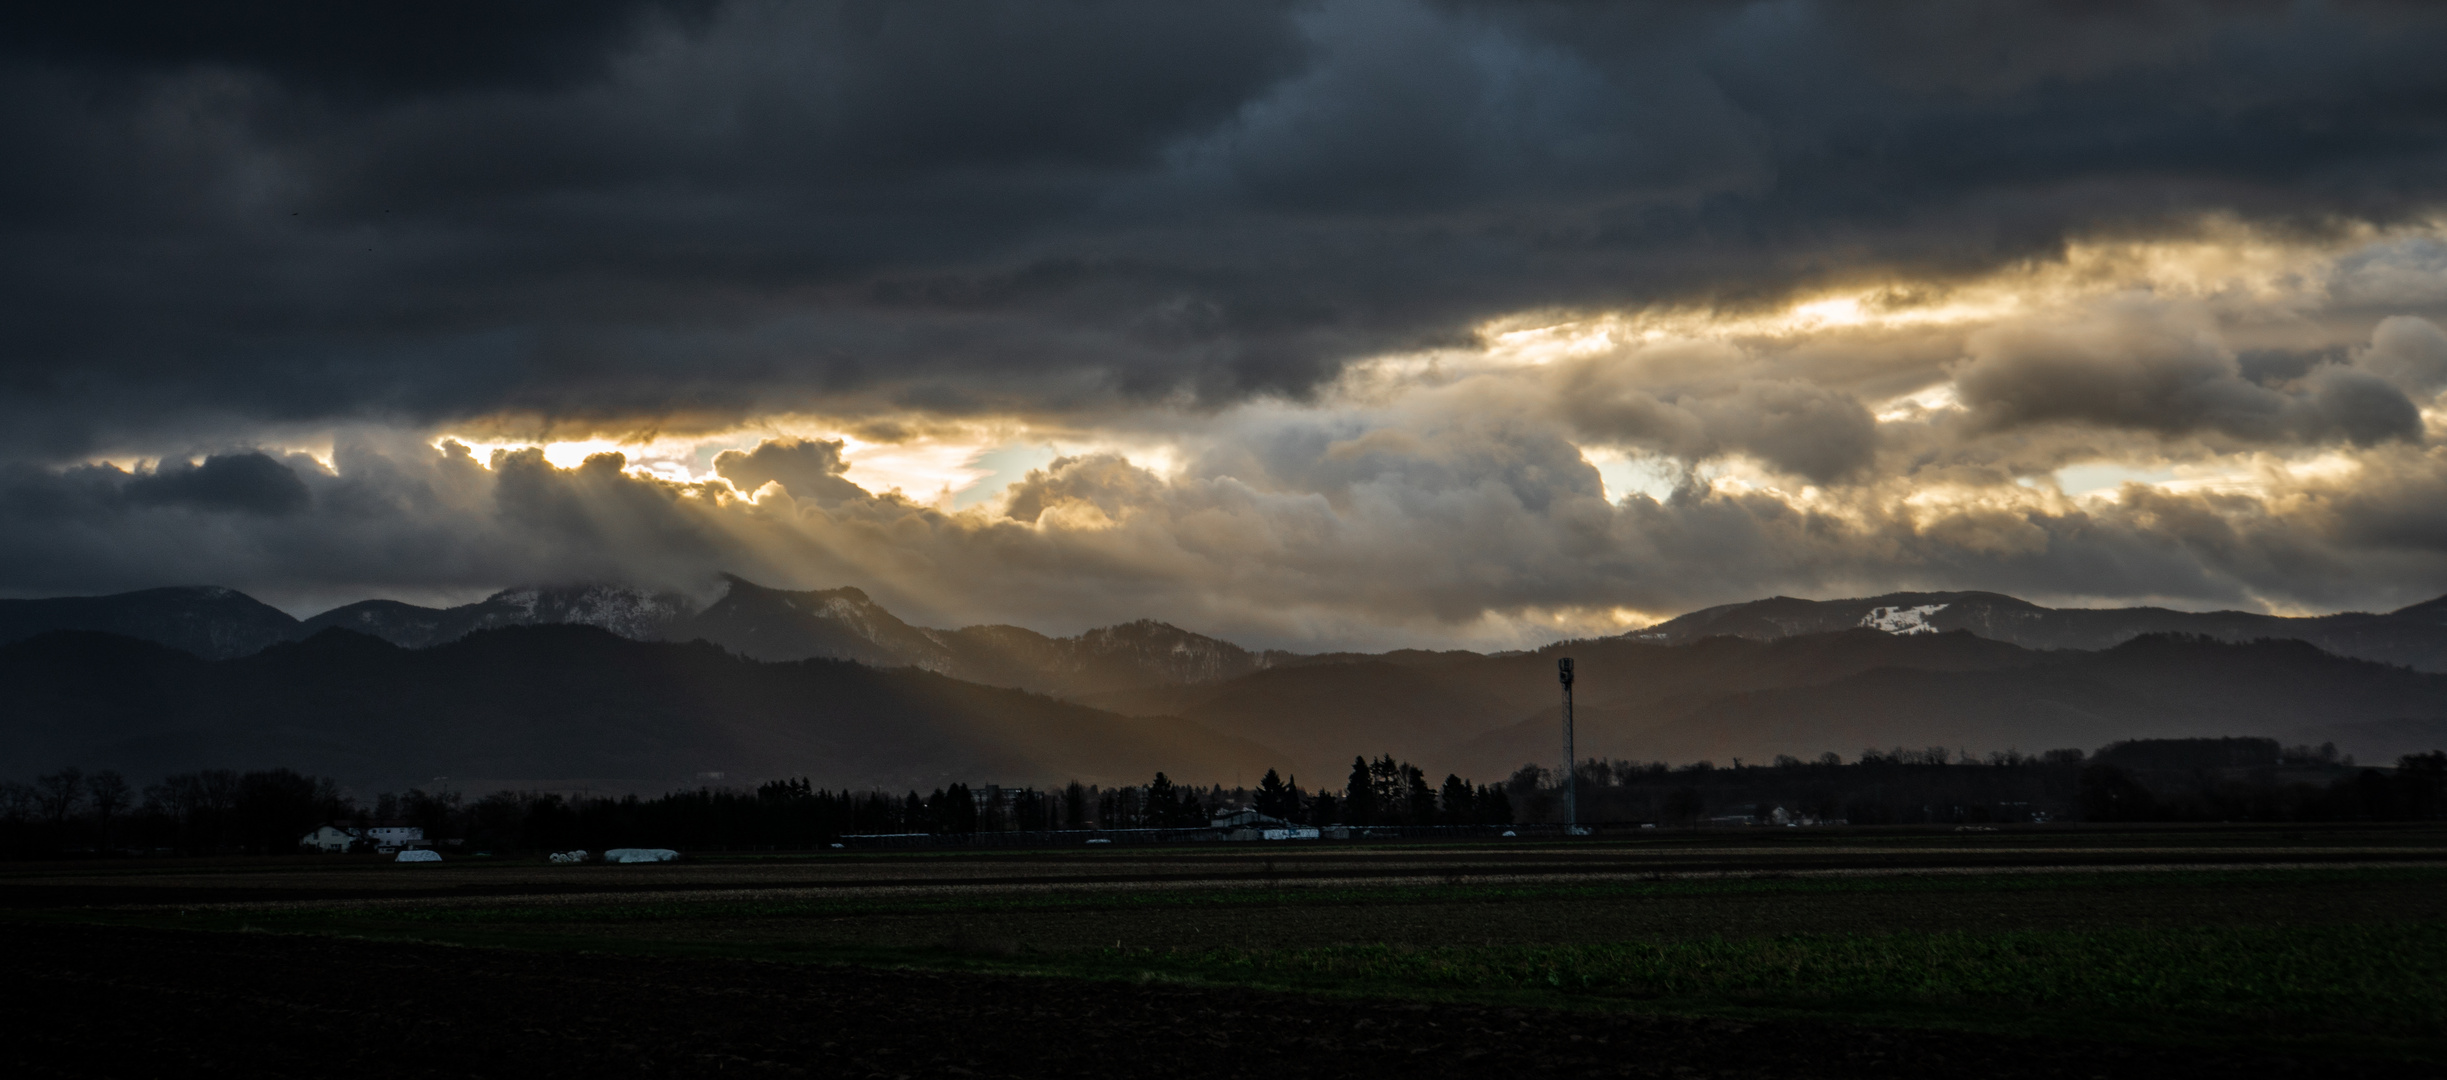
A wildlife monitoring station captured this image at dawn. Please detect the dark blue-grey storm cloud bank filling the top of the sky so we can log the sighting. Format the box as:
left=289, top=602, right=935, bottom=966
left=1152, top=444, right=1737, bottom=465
left=0, top=0, right=2447, bottom=460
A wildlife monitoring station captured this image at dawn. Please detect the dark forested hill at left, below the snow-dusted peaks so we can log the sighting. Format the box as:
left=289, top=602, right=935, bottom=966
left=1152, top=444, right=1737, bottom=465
left=0, top=624, right=1287, bottom=791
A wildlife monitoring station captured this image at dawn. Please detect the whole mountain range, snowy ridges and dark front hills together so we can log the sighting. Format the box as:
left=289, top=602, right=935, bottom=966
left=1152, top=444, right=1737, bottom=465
left=0, top=578, right=2447, bottom=791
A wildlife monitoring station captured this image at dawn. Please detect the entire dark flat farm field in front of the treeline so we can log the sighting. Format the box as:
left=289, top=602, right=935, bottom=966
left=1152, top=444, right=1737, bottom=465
left=0, top=828, right=2447, bottom=1078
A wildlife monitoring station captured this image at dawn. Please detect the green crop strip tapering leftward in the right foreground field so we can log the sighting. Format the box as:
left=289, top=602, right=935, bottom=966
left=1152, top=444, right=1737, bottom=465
left=1077, top=923, right=2447, bottom=1031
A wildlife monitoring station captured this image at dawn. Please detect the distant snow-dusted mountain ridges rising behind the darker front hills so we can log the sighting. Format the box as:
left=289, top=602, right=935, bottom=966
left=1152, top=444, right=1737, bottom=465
left=19, top=576, right=2447, bottom=675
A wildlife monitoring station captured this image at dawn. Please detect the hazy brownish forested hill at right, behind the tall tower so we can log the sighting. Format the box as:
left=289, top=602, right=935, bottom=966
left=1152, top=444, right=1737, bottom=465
left=1091, top=629, right=2447, bottom=776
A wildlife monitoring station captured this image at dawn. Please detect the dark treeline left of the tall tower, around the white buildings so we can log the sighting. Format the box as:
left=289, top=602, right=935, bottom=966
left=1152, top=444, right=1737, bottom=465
left=0, top=757, right=1512, bottom=857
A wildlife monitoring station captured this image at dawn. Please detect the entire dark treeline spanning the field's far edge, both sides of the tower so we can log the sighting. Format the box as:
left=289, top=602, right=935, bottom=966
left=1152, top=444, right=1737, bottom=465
left=14, top=740, right=2447, bottom=857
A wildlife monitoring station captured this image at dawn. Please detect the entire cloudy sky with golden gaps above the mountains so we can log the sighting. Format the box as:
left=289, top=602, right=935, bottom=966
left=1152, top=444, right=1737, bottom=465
left=0, top=0, right=2447, bottom=649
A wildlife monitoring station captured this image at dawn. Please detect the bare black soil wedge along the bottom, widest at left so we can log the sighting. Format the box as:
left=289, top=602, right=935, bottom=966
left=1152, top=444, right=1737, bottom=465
left=0, top=926, right=2368, bottom=1080
